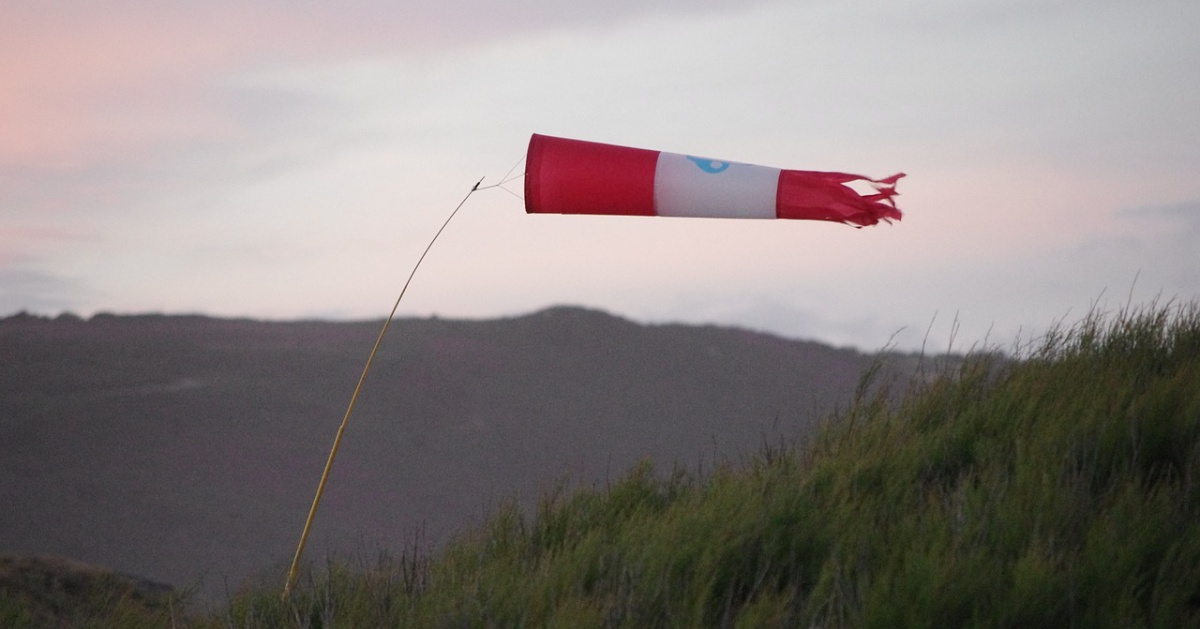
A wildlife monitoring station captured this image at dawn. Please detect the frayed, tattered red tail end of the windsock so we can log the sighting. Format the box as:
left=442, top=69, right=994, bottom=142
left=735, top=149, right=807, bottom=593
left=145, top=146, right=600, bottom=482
left=775, top=170, right=904, bottom=227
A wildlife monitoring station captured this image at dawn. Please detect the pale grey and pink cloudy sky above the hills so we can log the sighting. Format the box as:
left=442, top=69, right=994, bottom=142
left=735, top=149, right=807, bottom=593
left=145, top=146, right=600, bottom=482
left=0, top=0, right=1200, bottom=351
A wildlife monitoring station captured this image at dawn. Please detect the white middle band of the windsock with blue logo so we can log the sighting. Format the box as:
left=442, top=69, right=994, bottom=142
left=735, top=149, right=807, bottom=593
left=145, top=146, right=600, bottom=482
left=654, top=152, right=780, bottom=218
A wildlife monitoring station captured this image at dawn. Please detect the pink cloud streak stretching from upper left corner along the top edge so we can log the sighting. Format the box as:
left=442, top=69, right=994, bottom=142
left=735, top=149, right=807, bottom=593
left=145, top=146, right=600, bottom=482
left=0, top=0, right=768, bottom=169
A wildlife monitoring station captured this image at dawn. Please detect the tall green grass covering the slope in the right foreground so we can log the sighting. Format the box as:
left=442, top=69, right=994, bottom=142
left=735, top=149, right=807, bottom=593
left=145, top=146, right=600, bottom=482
left=196, top=305, right=1200, bottom=628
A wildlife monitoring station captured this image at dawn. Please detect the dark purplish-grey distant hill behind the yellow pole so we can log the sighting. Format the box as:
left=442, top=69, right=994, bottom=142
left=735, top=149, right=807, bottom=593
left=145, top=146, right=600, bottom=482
left=0, top=307, right=897, bottom=598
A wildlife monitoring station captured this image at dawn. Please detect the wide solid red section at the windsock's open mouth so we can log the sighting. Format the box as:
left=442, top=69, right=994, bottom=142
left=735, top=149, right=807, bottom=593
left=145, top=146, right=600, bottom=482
left=524, top=133, right=659, bottom=216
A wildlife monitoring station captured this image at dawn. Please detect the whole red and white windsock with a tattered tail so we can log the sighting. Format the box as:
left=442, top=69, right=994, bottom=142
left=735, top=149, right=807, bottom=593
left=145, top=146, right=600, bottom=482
left=524, top=133, right=904, bottom=227
